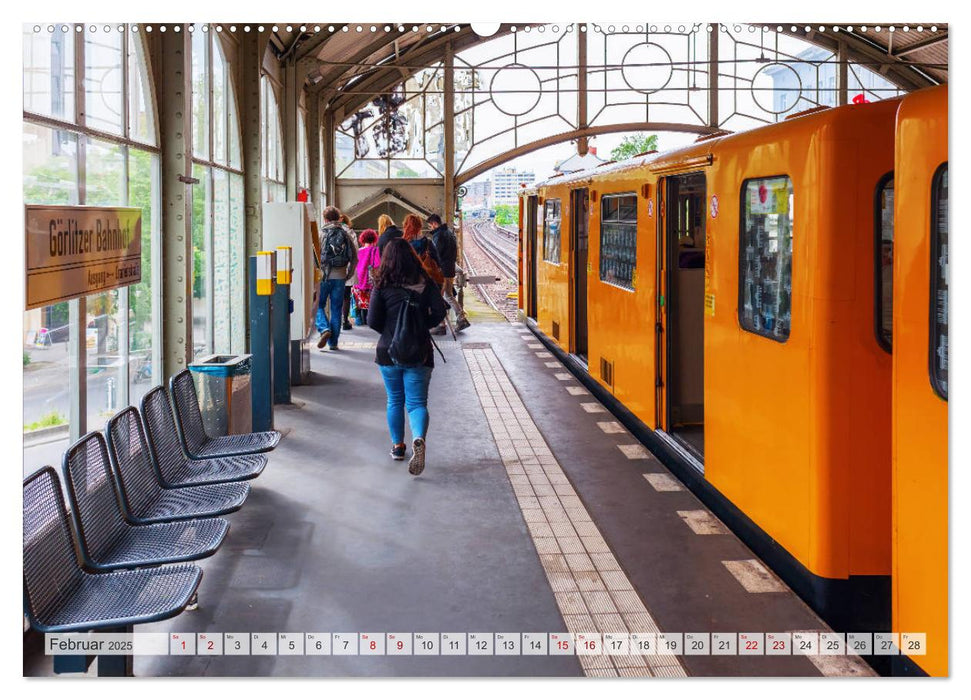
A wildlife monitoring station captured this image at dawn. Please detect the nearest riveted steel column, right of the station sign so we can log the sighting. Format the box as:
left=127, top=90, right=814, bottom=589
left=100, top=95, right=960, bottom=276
left=156, top=25, right=193, bottom=376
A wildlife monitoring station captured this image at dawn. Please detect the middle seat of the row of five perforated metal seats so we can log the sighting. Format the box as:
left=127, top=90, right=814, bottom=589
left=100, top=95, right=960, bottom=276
left=106, top=420, right=250, bottom=525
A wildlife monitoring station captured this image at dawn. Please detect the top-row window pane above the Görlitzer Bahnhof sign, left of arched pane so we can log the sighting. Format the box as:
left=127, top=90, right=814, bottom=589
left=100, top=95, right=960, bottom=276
left=84, top=28, right=125, bottom=135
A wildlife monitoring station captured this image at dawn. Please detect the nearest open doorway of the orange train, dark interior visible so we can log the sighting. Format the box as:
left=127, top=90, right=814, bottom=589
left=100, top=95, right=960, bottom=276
left=658, top=173, right=706, bottom=465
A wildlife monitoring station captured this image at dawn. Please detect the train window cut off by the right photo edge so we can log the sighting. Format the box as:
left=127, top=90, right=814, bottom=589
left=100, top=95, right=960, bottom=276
left=930, top=163, right=951, bottom=401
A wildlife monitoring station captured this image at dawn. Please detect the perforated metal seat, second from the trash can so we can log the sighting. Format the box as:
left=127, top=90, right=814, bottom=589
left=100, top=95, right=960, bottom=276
left=140, top=386, right=268, bottom=489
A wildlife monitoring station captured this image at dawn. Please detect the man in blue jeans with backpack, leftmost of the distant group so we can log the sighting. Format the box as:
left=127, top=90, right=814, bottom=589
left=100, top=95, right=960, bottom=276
left=317, top=207, right=357, bottom=350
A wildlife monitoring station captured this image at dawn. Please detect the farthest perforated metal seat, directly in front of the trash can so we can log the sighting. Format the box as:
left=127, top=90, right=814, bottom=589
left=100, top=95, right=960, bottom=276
left=169, top=369, right=280, bottom=459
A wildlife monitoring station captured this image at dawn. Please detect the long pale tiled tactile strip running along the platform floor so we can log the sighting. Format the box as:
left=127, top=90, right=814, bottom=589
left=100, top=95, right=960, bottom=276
left=463, top=348, right=687, bottom=678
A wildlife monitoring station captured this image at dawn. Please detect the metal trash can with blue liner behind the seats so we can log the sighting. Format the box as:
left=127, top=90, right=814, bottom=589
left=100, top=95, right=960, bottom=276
left=189, top=354, right=253, bottom=437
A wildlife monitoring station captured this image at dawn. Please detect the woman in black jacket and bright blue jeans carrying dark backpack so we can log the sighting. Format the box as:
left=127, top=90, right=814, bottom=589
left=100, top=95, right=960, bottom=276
left=367, top=239, right=448, bottom=476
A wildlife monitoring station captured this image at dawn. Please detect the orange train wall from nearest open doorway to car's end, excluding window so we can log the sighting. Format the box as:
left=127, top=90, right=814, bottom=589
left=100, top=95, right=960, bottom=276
left=705, top=102, right=896, bottom=579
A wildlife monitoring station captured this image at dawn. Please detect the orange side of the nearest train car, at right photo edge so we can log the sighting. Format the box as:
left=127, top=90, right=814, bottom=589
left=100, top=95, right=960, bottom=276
left=893, top=87, right=948, bottom=676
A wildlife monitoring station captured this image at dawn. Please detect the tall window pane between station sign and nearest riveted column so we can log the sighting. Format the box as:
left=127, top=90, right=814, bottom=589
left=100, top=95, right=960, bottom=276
left=128, top=148, right=158, bottom=405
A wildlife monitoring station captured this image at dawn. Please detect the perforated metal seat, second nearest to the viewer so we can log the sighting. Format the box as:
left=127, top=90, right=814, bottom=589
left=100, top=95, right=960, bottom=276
left=64, top=433, right=229, bottom=570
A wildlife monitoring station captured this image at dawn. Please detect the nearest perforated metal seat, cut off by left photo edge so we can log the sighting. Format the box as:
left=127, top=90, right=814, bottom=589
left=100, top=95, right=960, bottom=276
left=24, top=467, right=202, bottom=632
